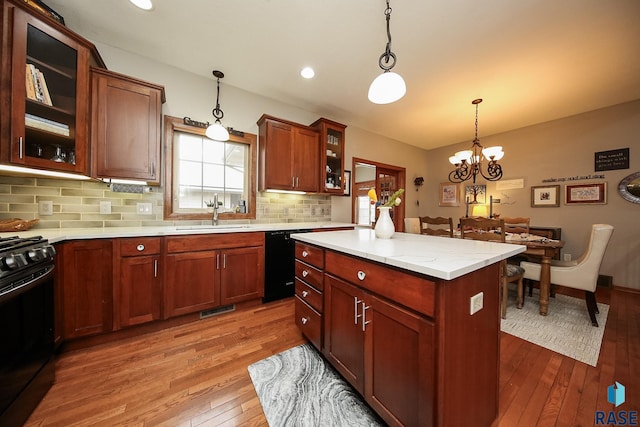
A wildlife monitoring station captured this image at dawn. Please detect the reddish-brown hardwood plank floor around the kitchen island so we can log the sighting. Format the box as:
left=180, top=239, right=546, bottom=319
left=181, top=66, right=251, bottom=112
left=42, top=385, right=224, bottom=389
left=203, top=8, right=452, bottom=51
left=26, top=289, right=640, bottom=427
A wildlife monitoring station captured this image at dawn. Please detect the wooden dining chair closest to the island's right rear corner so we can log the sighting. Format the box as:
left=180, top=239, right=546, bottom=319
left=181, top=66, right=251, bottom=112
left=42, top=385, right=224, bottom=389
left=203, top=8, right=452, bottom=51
left=460, top=218, right=524, bottom=319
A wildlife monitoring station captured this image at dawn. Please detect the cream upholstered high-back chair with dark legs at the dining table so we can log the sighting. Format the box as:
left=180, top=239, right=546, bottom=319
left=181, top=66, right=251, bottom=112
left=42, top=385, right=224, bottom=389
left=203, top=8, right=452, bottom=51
left=520, top=224, right=613, bottom=326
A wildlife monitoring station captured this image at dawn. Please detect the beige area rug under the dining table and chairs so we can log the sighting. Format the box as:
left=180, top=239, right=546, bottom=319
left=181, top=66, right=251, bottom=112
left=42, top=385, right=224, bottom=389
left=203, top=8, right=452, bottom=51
left=501, top=289, right=609, bottom=366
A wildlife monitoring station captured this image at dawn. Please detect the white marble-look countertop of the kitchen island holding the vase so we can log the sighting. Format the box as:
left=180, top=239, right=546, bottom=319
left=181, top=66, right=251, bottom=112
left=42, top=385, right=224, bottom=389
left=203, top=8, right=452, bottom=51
left=292, top=229, right=526, bottom=280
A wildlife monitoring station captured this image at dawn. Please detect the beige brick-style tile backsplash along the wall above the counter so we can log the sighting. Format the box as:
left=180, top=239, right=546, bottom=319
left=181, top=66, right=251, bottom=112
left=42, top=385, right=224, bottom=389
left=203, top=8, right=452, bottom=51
left=0, top=175, right=331, bottom=228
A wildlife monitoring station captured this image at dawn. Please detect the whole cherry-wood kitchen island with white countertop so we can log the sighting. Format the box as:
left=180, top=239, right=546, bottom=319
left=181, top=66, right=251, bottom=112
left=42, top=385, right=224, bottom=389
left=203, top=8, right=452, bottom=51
left=293, top=229, right=525, bottom=426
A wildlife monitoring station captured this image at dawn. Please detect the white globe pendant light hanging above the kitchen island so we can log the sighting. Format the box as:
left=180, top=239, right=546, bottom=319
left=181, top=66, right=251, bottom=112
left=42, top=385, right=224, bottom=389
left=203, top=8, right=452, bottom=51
left=369, top=0, right=407, bottom=104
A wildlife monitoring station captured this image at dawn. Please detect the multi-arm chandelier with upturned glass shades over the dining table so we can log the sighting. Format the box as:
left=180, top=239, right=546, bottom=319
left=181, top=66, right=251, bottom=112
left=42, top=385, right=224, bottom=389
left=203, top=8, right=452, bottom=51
left=449, top=99, right=504, bottom=183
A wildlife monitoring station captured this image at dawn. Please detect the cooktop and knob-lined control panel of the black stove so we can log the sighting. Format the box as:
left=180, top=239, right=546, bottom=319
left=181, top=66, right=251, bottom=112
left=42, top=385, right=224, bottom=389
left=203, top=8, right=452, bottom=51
left=0, top=236, right=56, bottom=298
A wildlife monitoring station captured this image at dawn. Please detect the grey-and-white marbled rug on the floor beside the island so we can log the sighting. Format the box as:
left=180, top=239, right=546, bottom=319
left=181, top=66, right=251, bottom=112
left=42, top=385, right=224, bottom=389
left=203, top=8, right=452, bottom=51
left=249, top=343, right=385, bottom=427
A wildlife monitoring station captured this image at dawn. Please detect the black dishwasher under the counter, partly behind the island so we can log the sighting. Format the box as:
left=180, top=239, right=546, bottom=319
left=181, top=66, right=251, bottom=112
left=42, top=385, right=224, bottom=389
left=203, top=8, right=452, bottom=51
left=262, top=230, right=311, bottom=302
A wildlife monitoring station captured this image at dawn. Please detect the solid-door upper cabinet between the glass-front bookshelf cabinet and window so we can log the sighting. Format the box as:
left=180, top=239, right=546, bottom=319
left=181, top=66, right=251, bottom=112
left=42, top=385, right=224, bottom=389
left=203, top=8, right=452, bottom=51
left=91, top=68, right=165, bottom=184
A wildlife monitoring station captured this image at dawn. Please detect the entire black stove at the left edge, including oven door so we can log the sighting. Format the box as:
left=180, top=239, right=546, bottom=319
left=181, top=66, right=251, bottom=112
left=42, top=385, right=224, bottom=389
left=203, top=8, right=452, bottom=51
left=0, top=236, right=56, bottom=426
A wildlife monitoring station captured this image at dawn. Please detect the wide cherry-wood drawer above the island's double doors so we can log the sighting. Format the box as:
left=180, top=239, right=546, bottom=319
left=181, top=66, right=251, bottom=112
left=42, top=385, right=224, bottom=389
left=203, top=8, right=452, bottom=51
left=325, top=251, right=436, bottom=317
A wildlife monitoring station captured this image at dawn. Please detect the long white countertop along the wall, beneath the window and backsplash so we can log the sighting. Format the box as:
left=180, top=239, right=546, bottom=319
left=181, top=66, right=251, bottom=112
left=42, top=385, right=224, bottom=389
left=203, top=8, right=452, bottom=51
left=0, top=222, right=355, bottom=243
